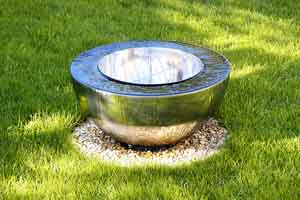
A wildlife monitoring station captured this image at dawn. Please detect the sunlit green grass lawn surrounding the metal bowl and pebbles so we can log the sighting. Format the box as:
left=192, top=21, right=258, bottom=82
left=0, top=0, right=300, bottom=199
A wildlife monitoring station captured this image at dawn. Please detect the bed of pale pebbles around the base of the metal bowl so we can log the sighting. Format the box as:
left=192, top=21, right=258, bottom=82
left=74, top=118, right=227, bottom=166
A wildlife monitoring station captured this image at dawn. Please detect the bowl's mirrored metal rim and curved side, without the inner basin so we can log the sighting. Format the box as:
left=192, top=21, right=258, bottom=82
left=71, top=41, right=230, bottom=145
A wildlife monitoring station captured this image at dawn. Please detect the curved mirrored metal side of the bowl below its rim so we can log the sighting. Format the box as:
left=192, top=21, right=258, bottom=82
left=74, top=78, right=228, bottom=145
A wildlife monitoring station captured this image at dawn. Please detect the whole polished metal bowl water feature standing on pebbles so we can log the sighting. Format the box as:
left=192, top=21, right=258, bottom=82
left=71, top=41, right=230, bottom=146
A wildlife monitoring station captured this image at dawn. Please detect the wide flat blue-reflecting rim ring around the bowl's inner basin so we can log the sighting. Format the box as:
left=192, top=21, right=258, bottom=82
left=70, top=40, right=230, bottom=97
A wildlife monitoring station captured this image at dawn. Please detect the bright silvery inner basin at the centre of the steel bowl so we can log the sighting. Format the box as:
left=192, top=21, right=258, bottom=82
left=98, top=47, right=204, bottom=85
